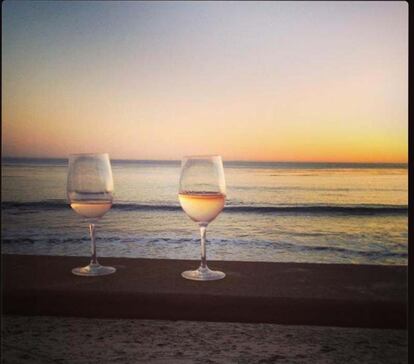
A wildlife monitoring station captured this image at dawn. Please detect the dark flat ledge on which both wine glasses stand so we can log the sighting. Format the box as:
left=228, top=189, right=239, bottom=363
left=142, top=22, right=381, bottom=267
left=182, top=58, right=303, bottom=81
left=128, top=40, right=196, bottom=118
left=2, top=255, right=407, bottom=328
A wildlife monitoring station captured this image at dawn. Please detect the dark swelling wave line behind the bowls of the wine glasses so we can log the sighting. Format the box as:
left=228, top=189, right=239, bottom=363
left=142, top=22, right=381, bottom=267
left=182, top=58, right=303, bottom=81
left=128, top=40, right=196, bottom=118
left=1, top=200, right=408, bottom=215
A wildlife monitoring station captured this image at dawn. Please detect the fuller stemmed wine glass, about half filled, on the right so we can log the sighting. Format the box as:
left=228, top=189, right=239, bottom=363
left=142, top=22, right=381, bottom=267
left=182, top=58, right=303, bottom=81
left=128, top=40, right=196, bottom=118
left=178, top=156, right=226, bottom=281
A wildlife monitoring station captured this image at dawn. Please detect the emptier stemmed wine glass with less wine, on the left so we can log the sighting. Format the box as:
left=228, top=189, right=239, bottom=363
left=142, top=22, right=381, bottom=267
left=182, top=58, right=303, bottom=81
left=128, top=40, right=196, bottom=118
left=67, top=153, right=116, bottom=276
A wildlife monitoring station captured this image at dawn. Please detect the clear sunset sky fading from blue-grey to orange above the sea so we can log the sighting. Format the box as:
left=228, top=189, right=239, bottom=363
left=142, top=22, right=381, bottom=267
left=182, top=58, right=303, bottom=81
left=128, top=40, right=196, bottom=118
left=2, top=1, right=408, bottom=163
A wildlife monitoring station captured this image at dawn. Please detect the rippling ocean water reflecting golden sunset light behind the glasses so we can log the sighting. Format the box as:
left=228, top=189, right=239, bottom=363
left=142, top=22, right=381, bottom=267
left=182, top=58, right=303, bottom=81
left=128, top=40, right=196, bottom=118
left=1, top=158, right=408, bottom=265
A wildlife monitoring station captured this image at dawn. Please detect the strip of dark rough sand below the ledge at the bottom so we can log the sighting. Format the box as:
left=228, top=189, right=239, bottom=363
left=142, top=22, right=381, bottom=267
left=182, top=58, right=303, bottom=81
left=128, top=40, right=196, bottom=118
left=2, top=315, right=408, bottom=364
